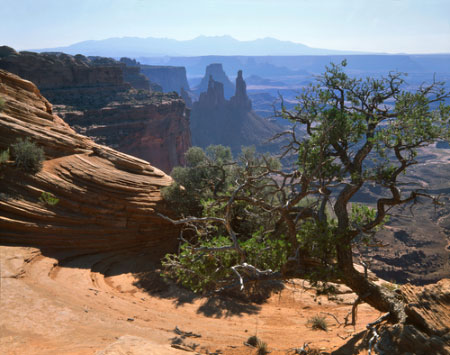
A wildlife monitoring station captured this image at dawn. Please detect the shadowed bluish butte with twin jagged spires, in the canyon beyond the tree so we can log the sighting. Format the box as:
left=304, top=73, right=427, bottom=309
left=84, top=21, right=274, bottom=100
left=191, top=71, right=280, bottom=153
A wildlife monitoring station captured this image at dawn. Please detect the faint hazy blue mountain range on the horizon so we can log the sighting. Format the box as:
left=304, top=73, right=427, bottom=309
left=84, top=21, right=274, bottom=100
left=35, top=36, right=363, bottom=57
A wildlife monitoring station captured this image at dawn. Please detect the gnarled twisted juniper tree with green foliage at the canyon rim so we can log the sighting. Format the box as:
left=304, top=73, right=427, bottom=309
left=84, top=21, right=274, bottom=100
left=164, top=62, right=450, bottom=322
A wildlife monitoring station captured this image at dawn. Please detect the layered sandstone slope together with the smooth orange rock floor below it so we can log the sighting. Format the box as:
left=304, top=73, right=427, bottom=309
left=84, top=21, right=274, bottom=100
left=0, top=66, right=386, bottom=355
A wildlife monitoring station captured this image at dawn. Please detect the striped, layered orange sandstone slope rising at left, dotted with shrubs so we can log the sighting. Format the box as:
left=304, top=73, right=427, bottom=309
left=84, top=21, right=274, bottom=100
left=0, top=70, right=178, bottom=251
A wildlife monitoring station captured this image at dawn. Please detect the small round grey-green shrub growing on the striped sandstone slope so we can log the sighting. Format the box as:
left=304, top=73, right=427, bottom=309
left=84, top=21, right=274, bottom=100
left=11, top=138, right=45, bottom=173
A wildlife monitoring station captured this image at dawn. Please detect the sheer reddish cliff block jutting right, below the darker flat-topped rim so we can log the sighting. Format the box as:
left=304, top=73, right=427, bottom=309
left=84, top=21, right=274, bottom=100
left=64, top=93, right=191, bottom=172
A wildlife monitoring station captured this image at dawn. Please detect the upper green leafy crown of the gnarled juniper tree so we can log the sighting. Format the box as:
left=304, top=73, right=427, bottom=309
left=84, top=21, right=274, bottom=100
left=285, top=62, right=450, bottom=189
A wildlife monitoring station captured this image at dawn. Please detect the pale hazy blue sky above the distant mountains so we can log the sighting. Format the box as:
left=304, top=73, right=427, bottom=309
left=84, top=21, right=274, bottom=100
left=0, top=0, right=450, bottom=53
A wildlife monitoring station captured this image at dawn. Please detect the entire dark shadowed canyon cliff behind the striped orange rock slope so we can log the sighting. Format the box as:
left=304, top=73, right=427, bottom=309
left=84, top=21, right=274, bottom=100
left=0, top=47, right=191, bottom=172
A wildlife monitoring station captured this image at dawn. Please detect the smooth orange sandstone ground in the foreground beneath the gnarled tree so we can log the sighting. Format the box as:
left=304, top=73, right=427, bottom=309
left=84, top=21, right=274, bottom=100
left=0, top=246, right=379, bottom=355
